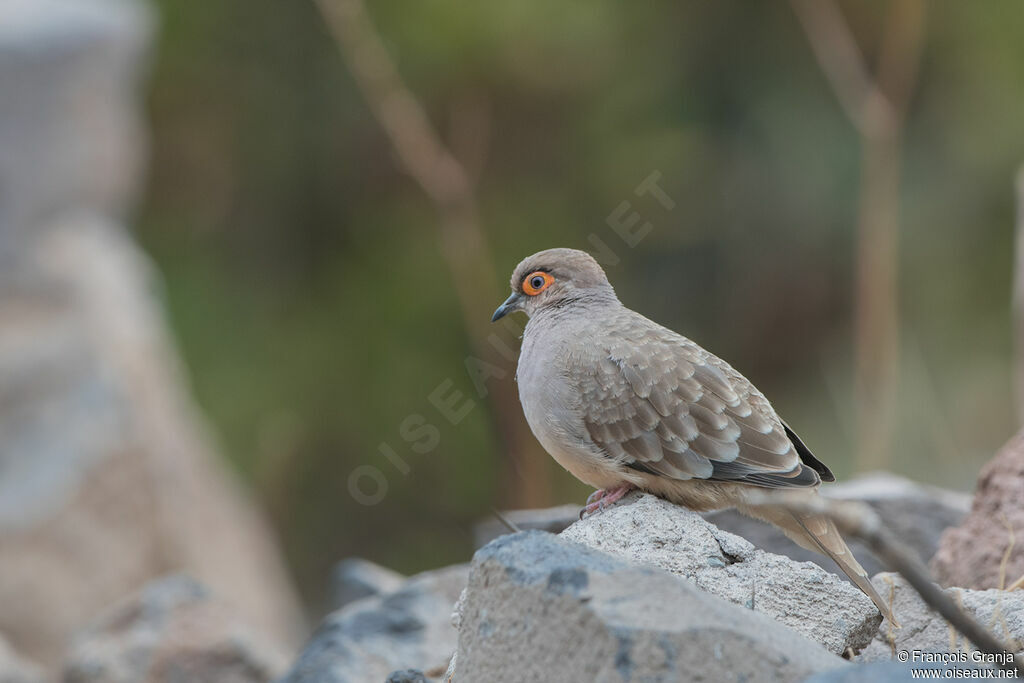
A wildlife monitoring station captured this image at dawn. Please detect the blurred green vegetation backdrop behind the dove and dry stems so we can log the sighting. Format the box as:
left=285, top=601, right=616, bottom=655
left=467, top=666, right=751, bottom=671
left=138, top=0, right=1024, bottom=602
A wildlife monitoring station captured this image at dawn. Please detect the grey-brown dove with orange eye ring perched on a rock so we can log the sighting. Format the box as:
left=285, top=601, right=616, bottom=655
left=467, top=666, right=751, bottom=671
left=492, top=249, right=895, bottom=625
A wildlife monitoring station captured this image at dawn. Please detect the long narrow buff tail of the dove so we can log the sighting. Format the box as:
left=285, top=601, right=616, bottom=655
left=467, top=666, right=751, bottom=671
left=742, top=507, right=899, bottom=628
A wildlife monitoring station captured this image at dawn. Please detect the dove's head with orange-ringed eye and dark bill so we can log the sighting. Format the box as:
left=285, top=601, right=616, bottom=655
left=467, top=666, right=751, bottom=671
left=490, top=249, right=616, bottom=323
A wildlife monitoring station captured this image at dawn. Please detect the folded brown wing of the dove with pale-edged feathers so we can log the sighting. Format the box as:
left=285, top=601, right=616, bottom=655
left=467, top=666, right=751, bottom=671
left=580, top=315, right=831, bottom=487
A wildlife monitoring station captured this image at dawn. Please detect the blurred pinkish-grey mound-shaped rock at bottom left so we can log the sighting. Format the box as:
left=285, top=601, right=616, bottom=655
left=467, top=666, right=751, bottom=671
left=63, top=577, right=287, bottom=683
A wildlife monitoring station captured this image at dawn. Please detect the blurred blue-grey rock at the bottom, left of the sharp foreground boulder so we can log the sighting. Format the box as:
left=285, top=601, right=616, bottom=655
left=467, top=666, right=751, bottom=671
left=283, top=565, right=469, bottom=683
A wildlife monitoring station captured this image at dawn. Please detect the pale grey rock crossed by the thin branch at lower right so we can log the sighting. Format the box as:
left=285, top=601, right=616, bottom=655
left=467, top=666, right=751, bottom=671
left=857, top=573, right=1024, bottom=661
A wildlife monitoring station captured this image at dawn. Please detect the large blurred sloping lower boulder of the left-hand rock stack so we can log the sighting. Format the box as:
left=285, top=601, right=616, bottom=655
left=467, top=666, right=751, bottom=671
left=0, top=220, right=304, bottom=669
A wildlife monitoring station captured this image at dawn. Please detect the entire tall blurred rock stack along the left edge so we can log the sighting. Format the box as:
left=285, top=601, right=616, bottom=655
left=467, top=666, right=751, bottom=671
left=0, top=0, right=304, bottom=670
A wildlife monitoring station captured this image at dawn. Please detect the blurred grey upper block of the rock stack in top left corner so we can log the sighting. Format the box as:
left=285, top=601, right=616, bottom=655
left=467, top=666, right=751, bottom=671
left=0, top=0, right=154, bottom=259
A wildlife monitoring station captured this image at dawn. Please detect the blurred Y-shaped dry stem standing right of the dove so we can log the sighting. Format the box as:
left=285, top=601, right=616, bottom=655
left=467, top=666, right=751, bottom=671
left=791, top=0, right=925, bottom=469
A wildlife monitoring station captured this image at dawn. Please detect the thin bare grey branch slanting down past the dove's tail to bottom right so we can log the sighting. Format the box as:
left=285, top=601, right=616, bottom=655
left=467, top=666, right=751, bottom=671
left=749, top=490, right=1024, bottom=676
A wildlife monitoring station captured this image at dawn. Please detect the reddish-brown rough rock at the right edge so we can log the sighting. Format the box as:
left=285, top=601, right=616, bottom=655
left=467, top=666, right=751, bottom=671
left=932, top=431, right=1024, bottom=589
